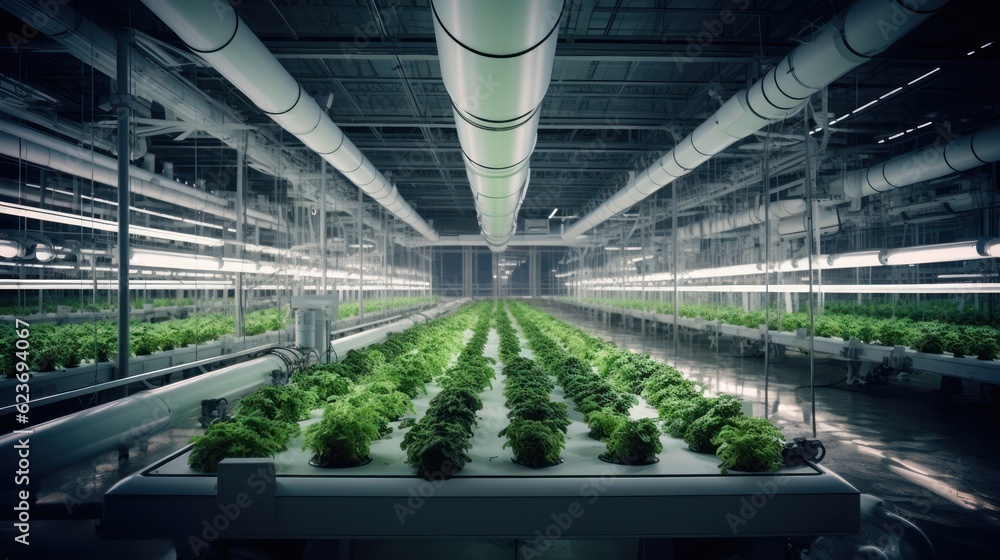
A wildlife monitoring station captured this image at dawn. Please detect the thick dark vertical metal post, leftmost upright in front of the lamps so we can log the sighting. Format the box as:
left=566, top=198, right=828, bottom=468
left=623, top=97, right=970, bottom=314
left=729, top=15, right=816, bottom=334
left=115, top=29, right=132, bottom=390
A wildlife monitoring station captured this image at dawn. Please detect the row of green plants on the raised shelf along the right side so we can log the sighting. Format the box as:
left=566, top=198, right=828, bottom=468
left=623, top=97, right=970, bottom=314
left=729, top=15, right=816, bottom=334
left=565, top=298, right=1000, bottom=360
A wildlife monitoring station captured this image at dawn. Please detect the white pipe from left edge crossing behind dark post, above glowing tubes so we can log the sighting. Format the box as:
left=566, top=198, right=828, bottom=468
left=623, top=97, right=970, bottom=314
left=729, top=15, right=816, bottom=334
left=0, top=130, right=279, bottom=229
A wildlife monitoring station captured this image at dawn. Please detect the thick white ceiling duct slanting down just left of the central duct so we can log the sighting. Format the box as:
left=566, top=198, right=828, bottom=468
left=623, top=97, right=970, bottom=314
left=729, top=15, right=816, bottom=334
left=143, top=0, right=438, bottom=241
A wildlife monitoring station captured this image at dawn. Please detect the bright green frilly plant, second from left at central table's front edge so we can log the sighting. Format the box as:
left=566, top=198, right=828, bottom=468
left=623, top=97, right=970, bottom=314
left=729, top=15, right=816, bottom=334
left=304, top=404, right=382, bottom=467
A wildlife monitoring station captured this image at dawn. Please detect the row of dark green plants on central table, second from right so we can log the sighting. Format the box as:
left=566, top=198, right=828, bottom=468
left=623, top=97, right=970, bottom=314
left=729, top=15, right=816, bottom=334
left=512, top=305, right=663, bottom=465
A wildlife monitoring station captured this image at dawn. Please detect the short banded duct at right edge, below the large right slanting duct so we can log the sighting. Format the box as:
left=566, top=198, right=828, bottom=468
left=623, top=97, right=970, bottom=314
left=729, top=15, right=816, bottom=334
left=830, top=124, right=1000, bottom=198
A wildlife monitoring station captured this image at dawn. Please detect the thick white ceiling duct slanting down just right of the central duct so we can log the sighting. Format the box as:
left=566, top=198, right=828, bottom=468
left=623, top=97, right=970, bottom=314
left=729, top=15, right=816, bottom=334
left=563, top=0, right=948, bottom=239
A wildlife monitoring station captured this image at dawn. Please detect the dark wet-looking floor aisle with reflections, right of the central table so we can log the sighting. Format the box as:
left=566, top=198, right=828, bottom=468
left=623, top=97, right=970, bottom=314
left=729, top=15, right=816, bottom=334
left=545, top=307, right=1000, bottom=559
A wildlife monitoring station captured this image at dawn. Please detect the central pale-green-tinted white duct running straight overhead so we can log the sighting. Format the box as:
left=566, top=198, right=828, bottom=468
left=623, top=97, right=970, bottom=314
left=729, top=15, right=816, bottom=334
left=431, top=0, right=563, bottom=252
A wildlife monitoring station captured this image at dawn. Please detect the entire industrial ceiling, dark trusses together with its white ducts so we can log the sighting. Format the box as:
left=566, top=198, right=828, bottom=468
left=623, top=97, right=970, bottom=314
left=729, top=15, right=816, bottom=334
left=0, top=0, right=1000, bottom=294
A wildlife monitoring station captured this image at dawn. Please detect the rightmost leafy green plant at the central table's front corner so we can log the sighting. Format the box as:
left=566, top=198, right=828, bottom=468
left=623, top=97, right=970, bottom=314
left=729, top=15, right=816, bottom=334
left=712, top=416, right=785, bottom=472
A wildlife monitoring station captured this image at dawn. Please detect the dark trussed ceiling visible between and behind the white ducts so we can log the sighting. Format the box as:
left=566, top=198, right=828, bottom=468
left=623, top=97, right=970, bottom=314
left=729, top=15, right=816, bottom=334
left=0, top=0, right=1000, bottom=241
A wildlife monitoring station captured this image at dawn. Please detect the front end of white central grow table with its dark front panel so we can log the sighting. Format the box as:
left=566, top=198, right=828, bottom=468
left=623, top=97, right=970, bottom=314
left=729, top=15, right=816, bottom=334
left=102, top=410, right=860, bottom=539
